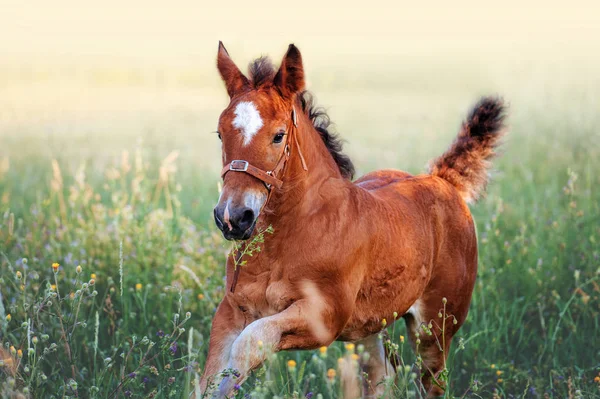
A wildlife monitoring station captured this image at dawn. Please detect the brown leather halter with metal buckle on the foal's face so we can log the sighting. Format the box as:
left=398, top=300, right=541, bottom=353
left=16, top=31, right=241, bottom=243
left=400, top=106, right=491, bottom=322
left=221, top=108, right=308, bottom=293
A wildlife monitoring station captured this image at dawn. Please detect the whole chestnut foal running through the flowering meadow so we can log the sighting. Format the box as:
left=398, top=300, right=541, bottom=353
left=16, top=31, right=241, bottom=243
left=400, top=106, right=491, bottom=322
left=200, top=43, right=504, bottom=398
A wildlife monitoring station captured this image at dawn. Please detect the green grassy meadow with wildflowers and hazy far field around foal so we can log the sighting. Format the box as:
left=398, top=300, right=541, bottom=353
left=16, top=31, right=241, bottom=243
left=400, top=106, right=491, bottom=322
left=0, top=45, right=600, bottom=398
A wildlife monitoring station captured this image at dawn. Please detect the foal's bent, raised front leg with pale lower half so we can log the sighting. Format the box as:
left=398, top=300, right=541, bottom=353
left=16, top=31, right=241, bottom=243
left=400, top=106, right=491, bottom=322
left=214, top=299, right=338, bottom=398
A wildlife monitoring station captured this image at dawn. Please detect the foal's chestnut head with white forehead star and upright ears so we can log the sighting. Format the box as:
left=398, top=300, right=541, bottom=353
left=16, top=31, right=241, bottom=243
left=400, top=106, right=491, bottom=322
left=214, top=43, right=304, bottom=240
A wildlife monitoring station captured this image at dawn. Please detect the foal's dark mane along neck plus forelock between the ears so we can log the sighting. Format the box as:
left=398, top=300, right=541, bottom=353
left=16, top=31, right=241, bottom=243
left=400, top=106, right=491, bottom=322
left=248, top=57, right=355, bottom=180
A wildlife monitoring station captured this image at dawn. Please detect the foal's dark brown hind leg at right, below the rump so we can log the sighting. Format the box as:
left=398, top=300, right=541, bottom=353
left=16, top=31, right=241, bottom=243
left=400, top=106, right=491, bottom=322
left=404, top=295, right=468, bottom=398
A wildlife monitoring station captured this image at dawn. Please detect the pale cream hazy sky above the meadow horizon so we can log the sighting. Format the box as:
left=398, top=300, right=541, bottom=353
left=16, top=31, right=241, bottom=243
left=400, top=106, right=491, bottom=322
left=0, top=0, right=600, bottom=62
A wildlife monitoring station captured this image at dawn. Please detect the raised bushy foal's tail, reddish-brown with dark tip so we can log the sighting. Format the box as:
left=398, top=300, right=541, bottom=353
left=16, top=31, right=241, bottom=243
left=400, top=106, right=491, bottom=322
left=429, top=97, right=505, bottom=203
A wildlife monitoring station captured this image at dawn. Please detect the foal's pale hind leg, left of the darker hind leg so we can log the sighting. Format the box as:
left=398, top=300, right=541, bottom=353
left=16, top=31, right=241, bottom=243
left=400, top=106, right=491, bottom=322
left=357, top=333, right=396, bottom=398
